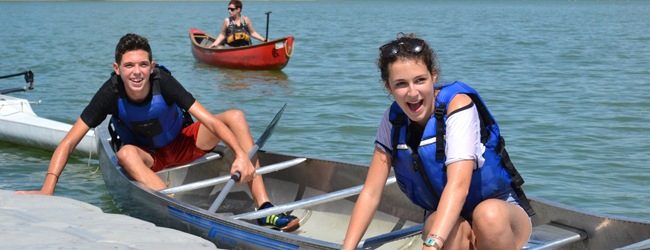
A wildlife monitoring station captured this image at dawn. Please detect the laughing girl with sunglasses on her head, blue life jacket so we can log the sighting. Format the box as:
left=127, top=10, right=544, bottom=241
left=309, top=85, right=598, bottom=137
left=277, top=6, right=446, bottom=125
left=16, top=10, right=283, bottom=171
left=343, top=33, right=533, bottom=250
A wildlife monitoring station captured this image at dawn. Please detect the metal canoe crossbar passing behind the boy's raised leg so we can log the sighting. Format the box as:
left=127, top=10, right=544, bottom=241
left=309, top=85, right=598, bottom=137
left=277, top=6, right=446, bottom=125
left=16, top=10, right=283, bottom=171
left=158, top=158, right=307, bottom=194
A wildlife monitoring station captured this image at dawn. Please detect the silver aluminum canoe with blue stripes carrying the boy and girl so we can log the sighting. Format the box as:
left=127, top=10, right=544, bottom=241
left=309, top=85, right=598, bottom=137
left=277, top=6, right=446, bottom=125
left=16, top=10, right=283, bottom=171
left=96, top=118, right=650, bottom=250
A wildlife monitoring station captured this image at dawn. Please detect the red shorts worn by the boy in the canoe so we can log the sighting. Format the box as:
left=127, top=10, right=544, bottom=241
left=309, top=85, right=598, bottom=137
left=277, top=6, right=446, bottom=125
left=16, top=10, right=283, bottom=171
left=139, top=121, right=210, bottom=172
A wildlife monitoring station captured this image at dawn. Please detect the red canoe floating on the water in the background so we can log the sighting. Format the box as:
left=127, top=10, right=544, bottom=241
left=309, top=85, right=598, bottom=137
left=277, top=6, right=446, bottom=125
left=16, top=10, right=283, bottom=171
left=190, top=28, right=294, bottom=70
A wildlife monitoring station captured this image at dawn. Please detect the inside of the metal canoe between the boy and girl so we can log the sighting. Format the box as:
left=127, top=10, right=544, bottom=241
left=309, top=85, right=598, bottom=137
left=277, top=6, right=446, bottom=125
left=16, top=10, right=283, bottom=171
left=158, top=146, right=424, bottom=249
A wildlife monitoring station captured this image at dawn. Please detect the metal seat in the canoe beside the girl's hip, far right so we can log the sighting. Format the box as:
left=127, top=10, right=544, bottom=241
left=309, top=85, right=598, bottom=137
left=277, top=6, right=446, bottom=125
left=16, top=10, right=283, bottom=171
left=523, top=222, right=587, bottom=250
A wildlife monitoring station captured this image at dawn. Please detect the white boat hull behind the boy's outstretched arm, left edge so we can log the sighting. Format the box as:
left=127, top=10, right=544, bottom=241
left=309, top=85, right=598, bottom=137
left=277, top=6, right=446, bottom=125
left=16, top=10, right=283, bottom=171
left=0, top=95, right=97, bottom=157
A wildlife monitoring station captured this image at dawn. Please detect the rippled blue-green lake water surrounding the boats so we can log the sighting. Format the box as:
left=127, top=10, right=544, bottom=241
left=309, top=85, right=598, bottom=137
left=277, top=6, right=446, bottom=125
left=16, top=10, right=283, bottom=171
left=0, top=1, right=650, bottom=219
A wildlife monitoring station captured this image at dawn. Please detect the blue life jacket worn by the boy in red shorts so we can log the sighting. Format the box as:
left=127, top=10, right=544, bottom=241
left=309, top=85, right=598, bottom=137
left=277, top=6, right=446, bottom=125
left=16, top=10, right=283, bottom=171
left=109, top=66, right=191, bottom=152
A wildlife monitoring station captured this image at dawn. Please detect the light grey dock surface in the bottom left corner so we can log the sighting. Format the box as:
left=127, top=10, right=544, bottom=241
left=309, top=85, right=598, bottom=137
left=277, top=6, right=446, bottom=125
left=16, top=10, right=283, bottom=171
left=0, top=190, right=223, bottom=250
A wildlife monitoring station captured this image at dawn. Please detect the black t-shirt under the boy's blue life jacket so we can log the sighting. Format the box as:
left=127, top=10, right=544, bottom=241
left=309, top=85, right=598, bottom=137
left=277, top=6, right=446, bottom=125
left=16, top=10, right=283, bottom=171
left=80, top=70, right=196, bottom=128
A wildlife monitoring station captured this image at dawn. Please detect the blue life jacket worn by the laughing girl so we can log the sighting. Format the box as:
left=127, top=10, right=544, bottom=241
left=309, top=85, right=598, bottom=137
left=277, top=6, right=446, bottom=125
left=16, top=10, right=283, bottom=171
left=389, top=82, right=534, bottom=215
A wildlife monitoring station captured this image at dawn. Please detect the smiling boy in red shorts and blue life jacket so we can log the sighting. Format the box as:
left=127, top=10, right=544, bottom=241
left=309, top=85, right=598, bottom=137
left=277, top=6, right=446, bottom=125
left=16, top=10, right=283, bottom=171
left=16, top=34, right=299, bottom=231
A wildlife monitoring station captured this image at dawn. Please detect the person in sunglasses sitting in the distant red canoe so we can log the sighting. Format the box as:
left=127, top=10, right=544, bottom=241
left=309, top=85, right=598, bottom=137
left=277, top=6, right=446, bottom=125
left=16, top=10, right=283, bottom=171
left=210, top=0, right=267, bottom=48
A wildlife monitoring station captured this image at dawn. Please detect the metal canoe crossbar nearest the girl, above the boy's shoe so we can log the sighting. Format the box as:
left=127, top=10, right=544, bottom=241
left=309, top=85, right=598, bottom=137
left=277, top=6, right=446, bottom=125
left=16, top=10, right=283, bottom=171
left=230, top=176, right=396, bottom=220
